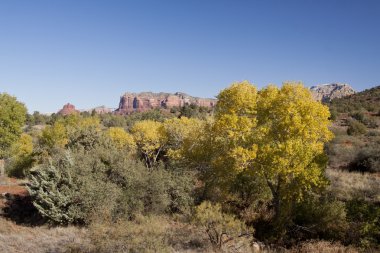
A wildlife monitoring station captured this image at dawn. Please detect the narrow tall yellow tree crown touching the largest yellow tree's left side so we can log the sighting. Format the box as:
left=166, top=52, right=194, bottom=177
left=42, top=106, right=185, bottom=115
left=211, top=81, right=257, bottom=171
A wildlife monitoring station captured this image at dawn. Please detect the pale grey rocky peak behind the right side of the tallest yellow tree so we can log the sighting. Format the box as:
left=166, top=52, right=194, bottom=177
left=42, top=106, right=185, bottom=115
left=310, top=83, right=355, bottom=102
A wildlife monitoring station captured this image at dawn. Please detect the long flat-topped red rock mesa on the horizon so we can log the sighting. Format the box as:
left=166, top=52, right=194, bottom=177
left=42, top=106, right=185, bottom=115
left=116, top=92, right=217, bottom=114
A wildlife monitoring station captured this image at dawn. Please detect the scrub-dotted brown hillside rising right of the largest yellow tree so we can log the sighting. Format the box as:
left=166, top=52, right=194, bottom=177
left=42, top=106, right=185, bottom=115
left=328, top=86, right=380, bottom=173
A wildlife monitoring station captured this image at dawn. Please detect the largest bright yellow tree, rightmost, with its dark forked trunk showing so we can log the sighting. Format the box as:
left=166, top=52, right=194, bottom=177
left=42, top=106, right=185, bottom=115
left=255, top=83, right=333, bottom=221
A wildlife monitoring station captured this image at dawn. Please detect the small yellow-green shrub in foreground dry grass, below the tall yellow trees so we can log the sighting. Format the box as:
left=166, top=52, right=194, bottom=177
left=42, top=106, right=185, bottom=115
left=194, top=201, right=252, bottom=248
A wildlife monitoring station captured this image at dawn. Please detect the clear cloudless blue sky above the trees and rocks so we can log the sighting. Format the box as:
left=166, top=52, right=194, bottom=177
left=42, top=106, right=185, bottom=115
left=0, top=0, right=380, bottom=112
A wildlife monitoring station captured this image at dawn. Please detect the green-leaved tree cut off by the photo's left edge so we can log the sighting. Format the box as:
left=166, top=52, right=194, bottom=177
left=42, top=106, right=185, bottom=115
left=0, top=93, right=27, bottom=159
